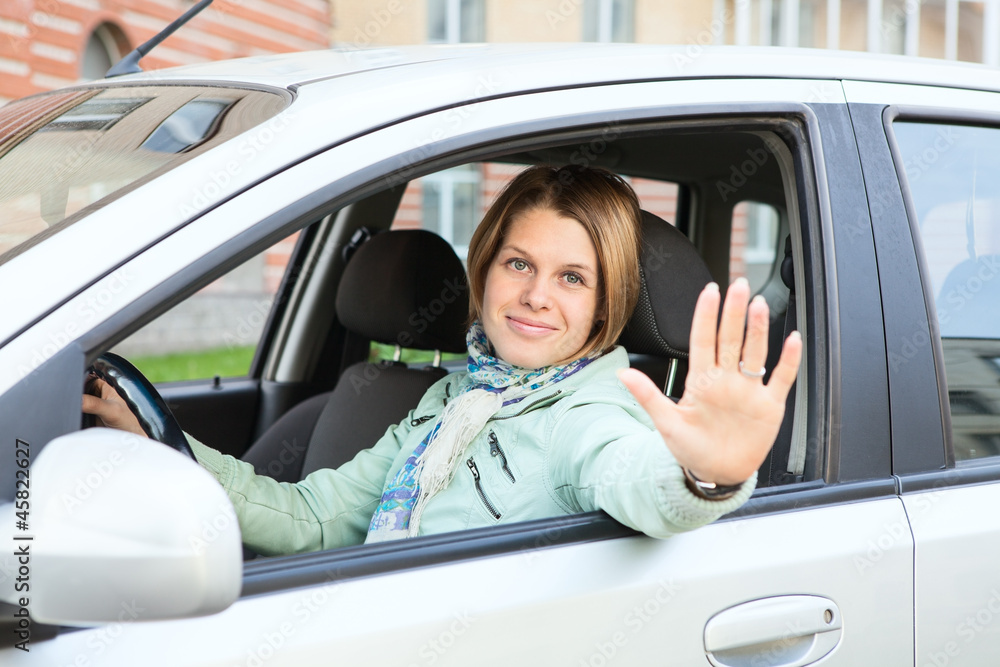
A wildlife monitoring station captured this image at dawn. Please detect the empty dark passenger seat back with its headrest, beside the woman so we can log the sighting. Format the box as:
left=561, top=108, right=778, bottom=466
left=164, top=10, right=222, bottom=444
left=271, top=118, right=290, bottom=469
left=243, top=230, right=469, bottom=481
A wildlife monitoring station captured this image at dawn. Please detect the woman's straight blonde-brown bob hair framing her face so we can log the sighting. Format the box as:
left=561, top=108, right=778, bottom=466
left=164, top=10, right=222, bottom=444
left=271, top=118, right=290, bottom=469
left=468, top=165, right=641, bottom=358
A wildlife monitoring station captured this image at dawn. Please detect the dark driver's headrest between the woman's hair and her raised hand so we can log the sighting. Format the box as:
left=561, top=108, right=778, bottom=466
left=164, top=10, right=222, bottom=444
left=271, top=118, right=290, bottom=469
left=618, top=211, right=712, bottom=359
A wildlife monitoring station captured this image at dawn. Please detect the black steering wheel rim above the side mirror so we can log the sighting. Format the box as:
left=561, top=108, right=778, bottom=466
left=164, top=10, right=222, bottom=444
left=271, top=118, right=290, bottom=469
left=84, top=352, right=195, bottom=459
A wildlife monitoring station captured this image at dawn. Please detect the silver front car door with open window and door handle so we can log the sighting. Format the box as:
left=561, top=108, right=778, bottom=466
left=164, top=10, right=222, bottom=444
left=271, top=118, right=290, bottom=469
left=0, top=79, right=914, bottom=667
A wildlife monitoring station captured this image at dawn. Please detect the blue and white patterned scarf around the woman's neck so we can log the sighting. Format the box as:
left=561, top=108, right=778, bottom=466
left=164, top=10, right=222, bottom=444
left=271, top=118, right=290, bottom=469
left=365, top=321, right=593, bottom=544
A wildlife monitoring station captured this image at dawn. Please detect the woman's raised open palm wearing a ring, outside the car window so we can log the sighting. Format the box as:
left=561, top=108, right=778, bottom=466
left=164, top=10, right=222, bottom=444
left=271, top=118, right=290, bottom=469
left=618, top=278, right=802, bottom=486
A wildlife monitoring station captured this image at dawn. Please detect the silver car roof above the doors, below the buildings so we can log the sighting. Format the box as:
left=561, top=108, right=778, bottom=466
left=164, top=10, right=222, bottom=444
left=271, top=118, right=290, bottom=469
left=99, top=43, right=1000, bottom=91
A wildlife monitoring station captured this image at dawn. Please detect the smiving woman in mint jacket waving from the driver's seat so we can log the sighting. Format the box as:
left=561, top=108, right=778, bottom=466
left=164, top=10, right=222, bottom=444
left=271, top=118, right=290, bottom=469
left=83, top=167, right=802, bottom=555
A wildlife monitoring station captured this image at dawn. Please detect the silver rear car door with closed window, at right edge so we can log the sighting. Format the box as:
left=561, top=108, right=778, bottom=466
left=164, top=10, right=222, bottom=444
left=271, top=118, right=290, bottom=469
left=846, top=82, right=1000, bottom=666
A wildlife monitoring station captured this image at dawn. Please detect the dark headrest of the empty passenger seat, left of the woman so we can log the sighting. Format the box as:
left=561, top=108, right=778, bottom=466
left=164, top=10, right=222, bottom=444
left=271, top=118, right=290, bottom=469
left=336, top=229, right=469, bottom=352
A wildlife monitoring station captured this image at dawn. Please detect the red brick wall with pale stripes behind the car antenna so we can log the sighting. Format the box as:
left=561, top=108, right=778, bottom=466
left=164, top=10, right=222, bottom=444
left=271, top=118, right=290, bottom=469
left=0, top=0, right=331, bottom=103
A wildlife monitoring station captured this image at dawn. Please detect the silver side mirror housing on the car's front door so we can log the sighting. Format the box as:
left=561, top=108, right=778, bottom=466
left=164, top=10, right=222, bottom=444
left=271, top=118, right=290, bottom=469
left=0, top=428, right=243, bottom=625
